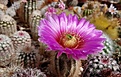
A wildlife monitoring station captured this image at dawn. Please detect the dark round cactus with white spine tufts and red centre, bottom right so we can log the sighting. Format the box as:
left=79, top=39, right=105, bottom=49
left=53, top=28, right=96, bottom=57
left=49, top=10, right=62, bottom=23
left=83, top=55, right=120, bottom=77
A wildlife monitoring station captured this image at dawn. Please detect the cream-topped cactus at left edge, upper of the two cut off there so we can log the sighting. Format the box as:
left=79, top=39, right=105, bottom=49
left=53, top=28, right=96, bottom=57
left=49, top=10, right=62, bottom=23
left=0, top=15, right=17, bottom=36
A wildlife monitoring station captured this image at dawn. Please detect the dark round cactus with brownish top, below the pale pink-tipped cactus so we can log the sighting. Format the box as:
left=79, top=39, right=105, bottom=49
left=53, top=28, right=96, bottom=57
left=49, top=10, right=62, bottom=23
left=16, top=46, right=38, bottom=68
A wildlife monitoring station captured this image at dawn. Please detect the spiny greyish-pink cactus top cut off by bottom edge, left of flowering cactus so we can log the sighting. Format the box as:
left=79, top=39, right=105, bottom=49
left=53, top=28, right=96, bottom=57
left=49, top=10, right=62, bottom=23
left=11, top=68, right=46, bottom=77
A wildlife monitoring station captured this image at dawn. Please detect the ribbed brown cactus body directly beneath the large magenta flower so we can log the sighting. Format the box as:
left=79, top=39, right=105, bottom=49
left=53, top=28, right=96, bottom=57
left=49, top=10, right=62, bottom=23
left=49, top=53, right=81, bottom=77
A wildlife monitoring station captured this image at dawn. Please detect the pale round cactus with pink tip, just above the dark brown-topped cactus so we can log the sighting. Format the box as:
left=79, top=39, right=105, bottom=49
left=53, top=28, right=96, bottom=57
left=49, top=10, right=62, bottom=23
left=11, top=31, right=31, bottom=50
